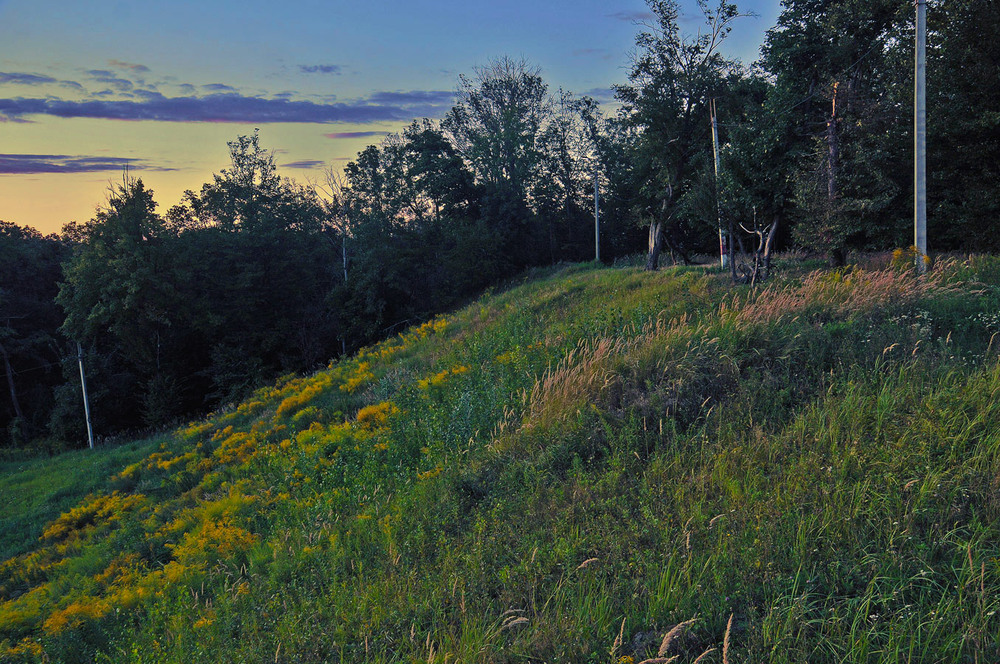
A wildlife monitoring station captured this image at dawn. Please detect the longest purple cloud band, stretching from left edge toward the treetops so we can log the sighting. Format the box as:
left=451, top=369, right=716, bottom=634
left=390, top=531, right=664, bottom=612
left=0, top=90, right=454, bottom=124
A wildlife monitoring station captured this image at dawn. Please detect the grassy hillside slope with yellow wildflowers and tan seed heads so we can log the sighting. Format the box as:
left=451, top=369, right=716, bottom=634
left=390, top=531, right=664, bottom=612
left=0, top=258, right=1000, bottom=664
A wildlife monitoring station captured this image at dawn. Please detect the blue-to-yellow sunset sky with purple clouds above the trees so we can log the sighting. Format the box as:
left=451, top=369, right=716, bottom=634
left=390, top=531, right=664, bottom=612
left=0, top=0, right=780, bottom=233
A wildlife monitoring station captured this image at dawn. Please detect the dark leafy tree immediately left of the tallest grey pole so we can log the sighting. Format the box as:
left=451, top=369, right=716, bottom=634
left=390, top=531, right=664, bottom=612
left=762, top=0, right=912, bottom=264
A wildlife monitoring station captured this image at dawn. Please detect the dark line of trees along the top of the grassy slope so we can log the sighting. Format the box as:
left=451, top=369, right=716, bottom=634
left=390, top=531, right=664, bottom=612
left=0, top=0, right=1000, bottom=447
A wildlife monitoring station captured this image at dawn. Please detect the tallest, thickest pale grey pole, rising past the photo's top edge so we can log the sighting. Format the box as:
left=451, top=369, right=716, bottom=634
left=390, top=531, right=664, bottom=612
left=913, top=0, right=927, bottom=273
